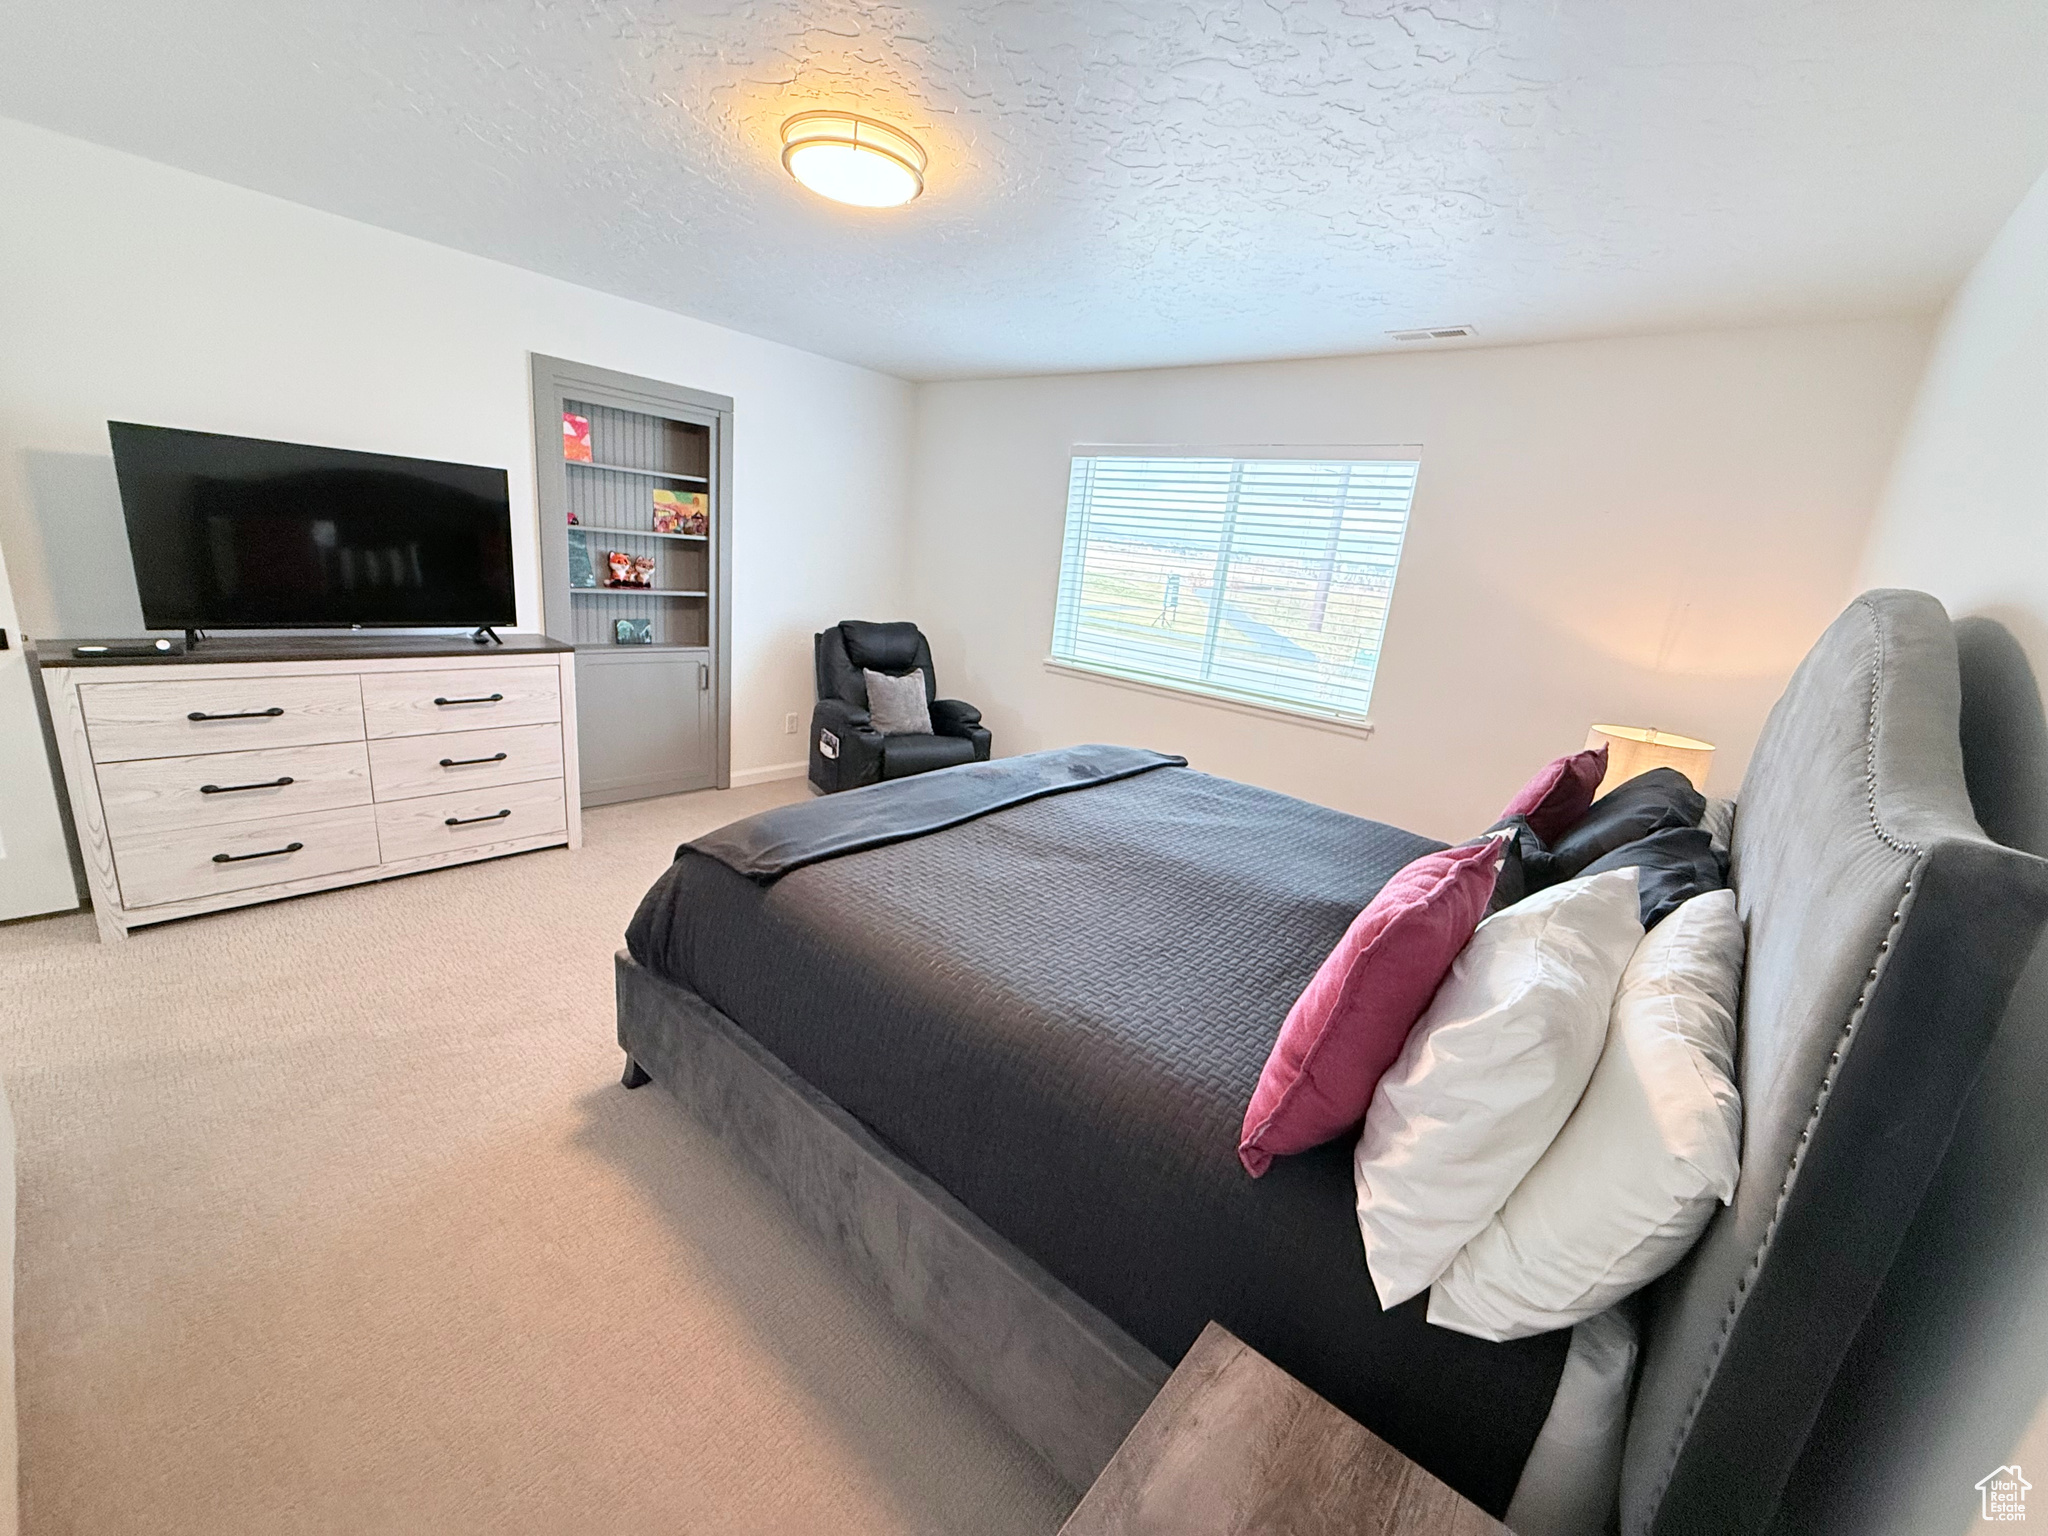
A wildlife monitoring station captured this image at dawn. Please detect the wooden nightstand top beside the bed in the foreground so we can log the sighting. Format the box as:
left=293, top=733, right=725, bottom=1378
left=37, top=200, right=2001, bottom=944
left=1061, top=1323, right=1507, bottom=1536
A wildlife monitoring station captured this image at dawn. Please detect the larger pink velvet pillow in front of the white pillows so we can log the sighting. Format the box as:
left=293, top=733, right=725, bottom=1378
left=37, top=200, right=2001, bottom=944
left=1237, top=838, right=1501, bottom=1178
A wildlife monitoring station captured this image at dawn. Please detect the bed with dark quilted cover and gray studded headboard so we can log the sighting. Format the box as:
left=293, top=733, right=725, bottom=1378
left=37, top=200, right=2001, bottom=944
left=618, top=592, right=2048, bottom=1532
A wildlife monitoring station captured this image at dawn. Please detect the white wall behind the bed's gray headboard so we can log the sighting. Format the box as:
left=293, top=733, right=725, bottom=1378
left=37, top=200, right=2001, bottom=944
left=1825, top=176, right=2048, bottom=1536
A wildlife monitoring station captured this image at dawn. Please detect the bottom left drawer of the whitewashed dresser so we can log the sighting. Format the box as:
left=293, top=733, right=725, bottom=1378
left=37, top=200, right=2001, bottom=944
left=113, top=805, right=377, bottom=907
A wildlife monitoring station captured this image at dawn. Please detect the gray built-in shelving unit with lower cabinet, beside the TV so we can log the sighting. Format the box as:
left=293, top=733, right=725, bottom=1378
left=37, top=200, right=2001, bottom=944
left=532, top=356, right=731, bottom=805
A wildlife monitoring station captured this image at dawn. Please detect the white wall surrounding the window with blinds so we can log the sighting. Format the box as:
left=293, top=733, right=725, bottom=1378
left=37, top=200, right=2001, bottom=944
left=913, top=319, right=1929, bottom=838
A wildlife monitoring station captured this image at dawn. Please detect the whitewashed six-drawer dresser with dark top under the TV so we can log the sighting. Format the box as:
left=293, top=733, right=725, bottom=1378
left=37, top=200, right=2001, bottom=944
left=37, top=635, right=582, bottom=942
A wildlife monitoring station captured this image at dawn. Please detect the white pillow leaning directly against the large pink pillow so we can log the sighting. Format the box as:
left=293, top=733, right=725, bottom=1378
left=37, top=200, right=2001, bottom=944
left=1352, top=868, right=1642, bottom=1307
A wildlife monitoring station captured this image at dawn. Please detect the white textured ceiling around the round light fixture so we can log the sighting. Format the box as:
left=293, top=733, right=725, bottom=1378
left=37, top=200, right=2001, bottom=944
left=0, top=0, right=2048, bottom=377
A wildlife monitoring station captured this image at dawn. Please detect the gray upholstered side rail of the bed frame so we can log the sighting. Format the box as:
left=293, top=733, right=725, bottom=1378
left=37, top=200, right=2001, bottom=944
left=616, top=950, right=1169, bottom=1493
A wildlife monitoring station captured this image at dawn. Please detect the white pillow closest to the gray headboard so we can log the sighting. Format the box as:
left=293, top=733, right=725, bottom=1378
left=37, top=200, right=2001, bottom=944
left=1430, top=891, right=1743, bottom=1339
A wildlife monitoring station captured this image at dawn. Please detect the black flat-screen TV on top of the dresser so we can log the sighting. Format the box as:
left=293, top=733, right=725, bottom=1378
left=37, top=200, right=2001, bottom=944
left=106, top=422, right=514, bottom=629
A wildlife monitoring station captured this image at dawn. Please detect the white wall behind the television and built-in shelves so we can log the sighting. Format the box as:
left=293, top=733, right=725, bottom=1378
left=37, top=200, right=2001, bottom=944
left=0, top=119, right=913, bottom=774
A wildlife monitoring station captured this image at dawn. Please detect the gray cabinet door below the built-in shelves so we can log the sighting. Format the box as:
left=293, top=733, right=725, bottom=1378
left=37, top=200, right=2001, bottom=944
left=575, top=645, right=717, bottom=805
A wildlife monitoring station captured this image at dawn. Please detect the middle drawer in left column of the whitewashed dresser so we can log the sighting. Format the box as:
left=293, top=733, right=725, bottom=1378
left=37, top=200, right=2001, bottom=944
left=98, top=741, right=371, bottom=840
